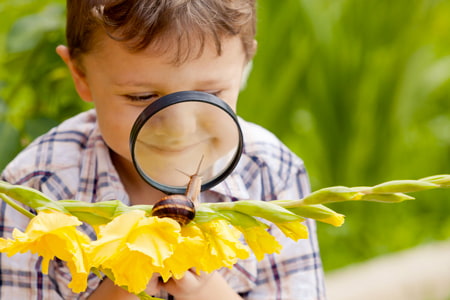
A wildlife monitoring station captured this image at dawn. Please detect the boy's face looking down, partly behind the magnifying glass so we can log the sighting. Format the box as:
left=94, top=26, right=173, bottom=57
left=57, top=35, right=246, bottom=184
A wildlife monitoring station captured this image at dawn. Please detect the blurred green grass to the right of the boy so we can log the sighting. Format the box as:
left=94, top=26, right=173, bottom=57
left=238, top=0, right=450, bottom=270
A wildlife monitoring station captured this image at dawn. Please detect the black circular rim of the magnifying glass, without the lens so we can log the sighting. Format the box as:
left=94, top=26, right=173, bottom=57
left=130, top=91, right=243, bottom=194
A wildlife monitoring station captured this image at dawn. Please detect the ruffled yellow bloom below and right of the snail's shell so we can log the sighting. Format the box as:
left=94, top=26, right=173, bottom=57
left=183, top=219, right=250, bottom=273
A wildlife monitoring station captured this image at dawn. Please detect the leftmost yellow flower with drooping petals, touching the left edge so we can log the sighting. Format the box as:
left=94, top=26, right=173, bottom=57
left=0, top=211, right=90, bottom=293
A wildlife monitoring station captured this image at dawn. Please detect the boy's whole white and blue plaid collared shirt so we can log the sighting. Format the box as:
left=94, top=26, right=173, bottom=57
left=0, top=110, right=325, bottom=300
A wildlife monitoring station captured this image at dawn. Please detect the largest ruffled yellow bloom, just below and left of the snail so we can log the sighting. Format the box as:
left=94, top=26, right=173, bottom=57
left=89, top=210, right=181, bottom=294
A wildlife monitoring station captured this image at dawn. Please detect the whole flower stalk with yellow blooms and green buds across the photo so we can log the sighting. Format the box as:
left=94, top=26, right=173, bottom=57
left=0, top=174, right=450, bottom=299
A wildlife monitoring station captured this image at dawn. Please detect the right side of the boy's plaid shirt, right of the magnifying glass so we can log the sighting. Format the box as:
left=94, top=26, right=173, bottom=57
left=222, top=120, right=326, bottom=300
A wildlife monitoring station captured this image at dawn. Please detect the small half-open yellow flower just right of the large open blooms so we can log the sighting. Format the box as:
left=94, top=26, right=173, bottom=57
left=237, top=226, right=282, bottom=260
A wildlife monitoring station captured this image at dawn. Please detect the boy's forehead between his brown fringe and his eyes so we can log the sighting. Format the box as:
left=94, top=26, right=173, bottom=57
left=83, top=33, right=250, bottom=91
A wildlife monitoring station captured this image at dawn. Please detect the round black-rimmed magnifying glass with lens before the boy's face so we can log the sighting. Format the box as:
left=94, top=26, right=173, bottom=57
left=130, top=91, right=243, bottom=194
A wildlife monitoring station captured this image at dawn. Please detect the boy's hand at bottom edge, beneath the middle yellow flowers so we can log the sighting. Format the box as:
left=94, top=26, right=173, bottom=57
left=158, top=270, right=242, bottom=300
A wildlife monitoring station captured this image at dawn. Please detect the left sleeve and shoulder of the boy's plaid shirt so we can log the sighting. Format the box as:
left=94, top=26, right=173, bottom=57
left=0, top=114, right=104, bottom=300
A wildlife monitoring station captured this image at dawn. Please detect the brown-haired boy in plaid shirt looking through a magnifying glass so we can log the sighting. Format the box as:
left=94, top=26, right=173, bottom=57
left=0, top=0, right=324, bottom=300
